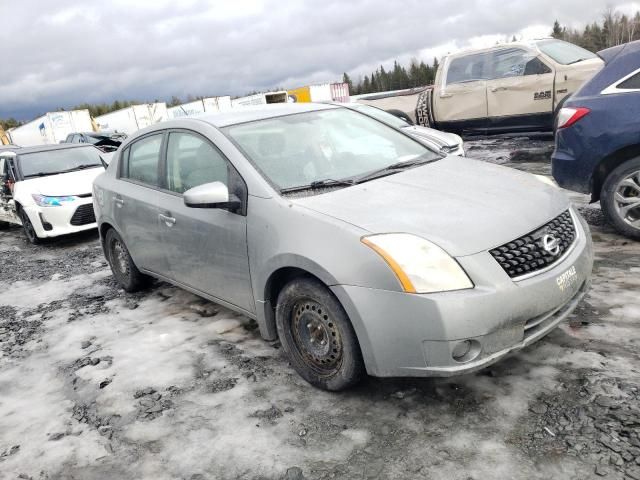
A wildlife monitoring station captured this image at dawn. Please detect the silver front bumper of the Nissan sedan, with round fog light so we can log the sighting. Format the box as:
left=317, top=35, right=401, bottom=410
left=332, top=210, right=593, bottom=377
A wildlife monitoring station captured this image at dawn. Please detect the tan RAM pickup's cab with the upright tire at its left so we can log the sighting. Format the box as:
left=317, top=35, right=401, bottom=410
left=416, top=38, right=602, bottom=133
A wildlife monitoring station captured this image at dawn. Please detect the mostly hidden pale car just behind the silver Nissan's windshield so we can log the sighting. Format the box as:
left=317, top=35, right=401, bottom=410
left=345, top=103, right=465, bottom=157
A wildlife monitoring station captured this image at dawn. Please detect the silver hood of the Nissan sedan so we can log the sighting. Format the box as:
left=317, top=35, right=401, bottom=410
left=291, top=156, right=569, bottom=256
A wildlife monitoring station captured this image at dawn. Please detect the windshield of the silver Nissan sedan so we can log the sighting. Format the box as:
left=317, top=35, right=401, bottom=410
left=224, top=108, right=442, bottom=190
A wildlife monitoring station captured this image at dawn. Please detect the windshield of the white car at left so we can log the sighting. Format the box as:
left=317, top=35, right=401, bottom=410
left=19, top=146, right=102, bottom=178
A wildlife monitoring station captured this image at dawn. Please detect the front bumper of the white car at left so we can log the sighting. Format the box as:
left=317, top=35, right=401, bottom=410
left=24, top=197, right=98, bottom=238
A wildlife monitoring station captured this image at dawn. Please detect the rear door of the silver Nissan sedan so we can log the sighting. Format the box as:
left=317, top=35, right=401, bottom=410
left=110, top=132, right=167, bottom=273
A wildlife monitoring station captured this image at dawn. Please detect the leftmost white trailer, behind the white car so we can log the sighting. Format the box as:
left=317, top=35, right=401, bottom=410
left=7, top=110, right=93, bottom=147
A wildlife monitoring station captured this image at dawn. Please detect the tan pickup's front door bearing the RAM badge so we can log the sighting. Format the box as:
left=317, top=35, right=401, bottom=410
left=487, top=47, right=554, bottom=130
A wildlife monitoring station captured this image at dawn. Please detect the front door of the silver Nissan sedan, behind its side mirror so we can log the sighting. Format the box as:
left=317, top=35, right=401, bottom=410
left=157, top=130, right=255, bottom=312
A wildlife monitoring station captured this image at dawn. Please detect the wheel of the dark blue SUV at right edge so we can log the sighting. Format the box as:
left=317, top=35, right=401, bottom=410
left=600, top=157, right=640, bottom=240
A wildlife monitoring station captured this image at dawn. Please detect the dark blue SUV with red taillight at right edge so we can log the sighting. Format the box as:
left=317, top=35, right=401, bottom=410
left=552, top=41, right=640, bottom=240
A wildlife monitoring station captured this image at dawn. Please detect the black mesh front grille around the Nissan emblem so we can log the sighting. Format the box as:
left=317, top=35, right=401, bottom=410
left=489, top=210, right=576, bottom=278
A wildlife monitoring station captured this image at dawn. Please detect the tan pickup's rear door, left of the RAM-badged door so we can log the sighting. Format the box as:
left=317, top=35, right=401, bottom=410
left=434, top=53, right=488, bottom=131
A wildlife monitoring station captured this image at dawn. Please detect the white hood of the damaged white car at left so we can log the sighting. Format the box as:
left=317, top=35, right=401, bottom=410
left=19, top=167, right=104, bottom=196
